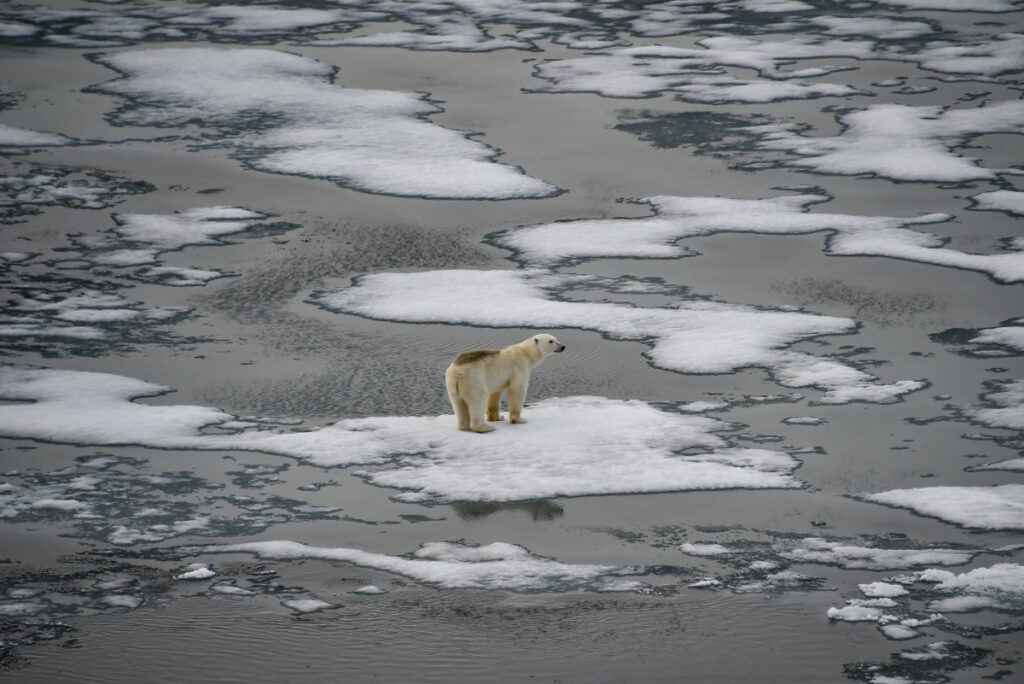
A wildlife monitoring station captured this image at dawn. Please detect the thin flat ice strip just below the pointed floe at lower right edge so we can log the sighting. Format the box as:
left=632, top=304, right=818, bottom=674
left=779, top=537, right=975, bottom=570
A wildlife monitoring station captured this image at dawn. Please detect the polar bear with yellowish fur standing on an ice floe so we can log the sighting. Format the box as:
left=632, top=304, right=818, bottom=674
left=444, top=334, right=565, bottom=432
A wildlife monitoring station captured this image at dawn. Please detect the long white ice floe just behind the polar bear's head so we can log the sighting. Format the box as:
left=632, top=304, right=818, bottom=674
left=315, top=269, right=925, bottom=403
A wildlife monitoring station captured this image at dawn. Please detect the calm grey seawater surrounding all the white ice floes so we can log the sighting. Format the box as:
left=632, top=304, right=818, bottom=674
left=0, top=3, right=1024, bottom=682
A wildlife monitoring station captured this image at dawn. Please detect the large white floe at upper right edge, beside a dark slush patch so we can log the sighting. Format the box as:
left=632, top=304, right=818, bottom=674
left=746, top=100, right=1024, bottom=183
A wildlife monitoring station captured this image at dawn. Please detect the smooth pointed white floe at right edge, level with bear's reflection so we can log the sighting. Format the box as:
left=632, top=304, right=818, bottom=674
left=863, top=484, right=1024, bottom=529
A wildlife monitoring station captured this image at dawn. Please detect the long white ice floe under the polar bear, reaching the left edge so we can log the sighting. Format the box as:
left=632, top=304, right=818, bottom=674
left=0, top=367, right=802, bottom=499
